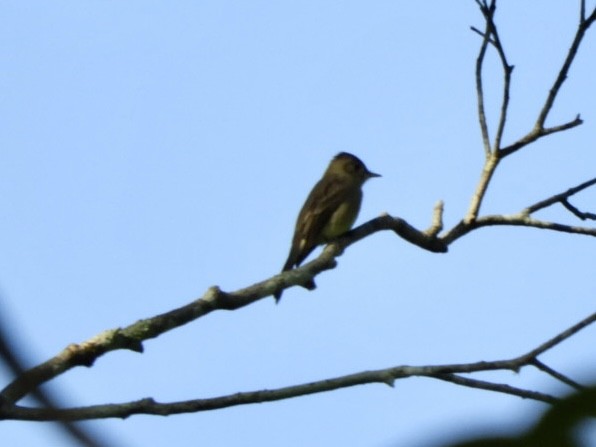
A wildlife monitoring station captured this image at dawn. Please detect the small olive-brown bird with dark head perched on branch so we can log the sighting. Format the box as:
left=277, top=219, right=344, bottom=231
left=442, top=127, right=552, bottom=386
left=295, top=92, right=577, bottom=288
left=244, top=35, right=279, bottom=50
left=273, top=152, right=381, bottom=303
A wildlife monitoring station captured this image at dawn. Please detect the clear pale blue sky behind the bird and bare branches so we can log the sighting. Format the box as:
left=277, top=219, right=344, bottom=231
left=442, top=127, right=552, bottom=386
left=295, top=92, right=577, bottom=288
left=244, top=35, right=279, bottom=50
left=0, top=0, right=596, bottom=447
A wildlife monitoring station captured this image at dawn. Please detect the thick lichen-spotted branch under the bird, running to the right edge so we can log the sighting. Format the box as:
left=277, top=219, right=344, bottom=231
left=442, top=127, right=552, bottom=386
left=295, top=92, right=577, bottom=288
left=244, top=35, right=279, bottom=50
left=9, top=172, right=596, bottom=410
